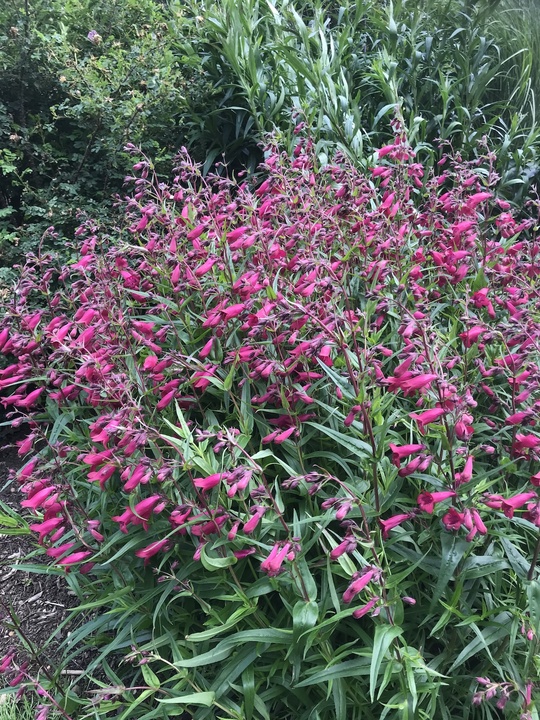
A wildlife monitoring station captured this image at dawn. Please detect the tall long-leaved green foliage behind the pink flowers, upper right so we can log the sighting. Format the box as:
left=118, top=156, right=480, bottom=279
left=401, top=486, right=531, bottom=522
left=182, top=0, right=538, bottom=194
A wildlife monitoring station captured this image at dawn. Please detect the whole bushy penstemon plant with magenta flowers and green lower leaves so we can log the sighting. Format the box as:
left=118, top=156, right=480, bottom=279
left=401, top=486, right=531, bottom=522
left=0, top=116, right=540, bottom=720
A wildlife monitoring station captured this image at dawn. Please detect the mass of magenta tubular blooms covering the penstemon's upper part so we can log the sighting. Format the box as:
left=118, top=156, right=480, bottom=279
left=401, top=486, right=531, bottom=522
left=0, top=120, right=540, bottom=716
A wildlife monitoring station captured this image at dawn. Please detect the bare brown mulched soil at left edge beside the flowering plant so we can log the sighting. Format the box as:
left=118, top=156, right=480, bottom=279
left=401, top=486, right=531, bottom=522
left=0, top=436, right=81, bottom=671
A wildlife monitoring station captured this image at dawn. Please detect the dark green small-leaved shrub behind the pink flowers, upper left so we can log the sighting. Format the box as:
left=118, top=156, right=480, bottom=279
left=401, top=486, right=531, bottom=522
left=0, top=0, right=212, bottom=281
